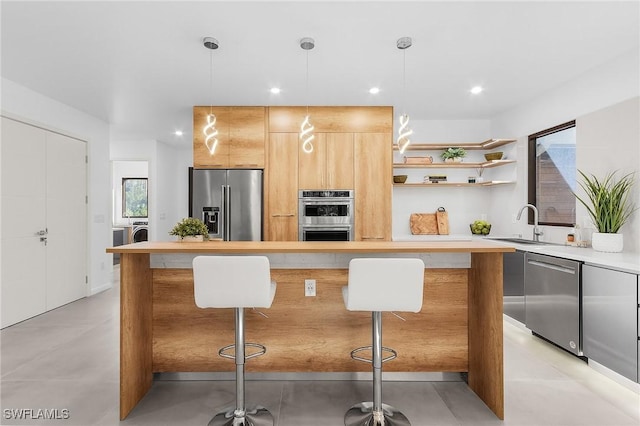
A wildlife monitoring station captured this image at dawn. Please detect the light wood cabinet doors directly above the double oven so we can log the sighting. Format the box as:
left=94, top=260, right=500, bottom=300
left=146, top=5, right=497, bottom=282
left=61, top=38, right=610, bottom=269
left=298, top=133, right=354, bottom=189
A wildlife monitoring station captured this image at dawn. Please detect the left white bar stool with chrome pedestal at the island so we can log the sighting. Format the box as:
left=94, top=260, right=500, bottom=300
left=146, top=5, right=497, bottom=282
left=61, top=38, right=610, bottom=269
left=193, top=256, right=276, bottom=426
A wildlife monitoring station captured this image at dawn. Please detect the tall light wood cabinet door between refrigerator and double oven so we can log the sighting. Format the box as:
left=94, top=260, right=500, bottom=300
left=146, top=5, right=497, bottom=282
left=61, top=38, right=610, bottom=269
left=265, top=133, right=298, bottom=241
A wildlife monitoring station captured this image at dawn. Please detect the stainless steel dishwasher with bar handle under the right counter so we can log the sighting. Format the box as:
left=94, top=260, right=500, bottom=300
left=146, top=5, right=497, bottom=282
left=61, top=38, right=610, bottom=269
left=524, top=253, right=582, bottom=356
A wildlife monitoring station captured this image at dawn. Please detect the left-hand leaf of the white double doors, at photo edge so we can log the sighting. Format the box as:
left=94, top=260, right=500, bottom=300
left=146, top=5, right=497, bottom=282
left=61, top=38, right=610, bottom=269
left=0, top=117, right=47, bottom=327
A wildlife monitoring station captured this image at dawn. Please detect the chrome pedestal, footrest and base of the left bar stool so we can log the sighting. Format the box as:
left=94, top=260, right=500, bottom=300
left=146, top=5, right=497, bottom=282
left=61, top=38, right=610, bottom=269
left=208, top=308, right=273, bottom=426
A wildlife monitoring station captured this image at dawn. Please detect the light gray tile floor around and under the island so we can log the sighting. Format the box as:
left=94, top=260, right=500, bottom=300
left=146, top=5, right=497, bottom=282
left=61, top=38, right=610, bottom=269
left=0, top=270, right=640, bottom=426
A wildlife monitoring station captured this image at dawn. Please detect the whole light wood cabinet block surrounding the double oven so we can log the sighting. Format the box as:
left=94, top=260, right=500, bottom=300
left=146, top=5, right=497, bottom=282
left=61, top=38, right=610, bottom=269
left=265, top=107, right=393, bottom=241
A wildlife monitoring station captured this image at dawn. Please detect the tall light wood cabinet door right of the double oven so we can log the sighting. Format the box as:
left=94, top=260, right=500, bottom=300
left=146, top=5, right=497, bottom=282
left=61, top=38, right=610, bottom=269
left=354, top=133, right=393, bottom=241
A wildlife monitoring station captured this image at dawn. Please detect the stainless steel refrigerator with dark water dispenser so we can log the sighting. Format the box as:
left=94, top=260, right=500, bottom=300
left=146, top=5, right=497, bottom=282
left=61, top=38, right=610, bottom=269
left=189, top=167, right=263, bottom=241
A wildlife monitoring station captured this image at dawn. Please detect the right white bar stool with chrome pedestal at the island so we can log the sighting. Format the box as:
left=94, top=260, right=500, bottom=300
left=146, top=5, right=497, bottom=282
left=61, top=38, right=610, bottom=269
left=342, top=258, right=424, bottom=426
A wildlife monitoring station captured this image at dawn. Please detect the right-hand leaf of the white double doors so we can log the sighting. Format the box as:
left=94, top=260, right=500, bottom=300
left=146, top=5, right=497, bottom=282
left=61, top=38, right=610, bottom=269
left=46, top=132, right=87, bottom=310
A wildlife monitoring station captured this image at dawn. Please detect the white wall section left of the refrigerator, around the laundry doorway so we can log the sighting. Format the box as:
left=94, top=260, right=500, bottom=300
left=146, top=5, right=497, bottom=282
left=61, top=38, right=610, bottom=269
left=111, top=140, right=193, bottom=241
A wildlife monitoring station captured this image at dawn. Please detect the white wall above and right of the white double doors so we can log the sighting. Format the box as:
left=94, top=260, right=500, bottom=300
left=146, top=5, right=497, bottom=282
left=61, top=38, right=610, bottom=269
left=1, top=78, right=112, bottom=294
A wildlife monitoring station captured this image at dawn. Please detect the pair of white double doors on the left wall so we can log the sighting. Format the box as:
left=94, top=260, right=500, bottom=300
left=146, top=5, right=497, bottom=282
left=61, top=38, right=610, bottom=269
left=0, top=117, right=87, bottom=328
